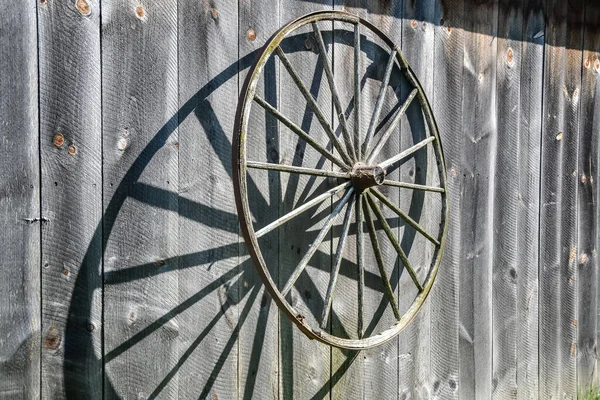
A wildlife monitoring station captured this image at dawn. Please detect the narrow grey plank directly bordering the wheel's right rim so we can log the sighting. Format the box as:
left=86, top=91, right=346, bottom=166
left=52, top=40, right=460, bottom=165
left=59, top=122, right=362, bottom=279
left=430, top=1, right=470, bottom=399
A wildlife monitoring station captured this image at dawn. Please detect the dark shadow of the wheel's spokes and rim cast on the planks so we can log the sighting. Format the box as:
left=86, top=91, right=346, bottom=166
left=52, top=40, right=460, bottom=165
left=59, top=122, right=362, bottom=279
left=63, top=26, right=436, bottom=399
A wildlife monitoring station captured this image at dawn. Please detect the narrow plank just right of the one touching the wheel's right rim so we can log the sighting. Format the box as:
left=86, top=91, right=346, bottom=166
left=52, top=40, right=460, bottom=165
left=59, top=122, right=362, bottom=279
left=458, top=0, right=496, bottom=398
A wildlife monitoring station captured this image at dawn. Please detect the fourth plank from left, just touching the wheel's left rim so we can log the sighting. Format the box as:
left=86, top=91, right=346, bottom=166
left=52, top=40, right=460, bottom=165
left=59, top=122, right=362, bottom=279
left=178, top=0, right=239, bottom=399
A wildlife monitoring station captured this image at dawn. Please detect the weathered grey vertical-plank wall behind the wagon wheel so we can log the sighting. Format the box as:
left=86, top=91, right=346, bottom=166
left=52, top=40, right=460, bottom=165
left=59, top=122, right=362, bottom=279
left=0, top=0, right=600, bottom=399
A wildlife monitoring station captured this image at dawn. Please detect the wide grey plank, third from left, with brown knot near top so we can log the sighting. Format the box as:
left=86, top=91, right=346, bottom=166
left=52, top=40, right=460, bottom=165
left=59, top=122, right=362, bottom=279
left=102, top=0, right=179, bottom=398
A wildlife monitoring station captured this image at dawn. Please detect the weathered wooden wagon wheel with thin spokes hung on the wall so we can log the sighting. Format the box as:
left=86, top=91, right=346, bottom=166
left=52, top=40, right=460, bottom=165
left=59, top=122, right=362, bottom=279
left=233, top=11, right=448, bottom=349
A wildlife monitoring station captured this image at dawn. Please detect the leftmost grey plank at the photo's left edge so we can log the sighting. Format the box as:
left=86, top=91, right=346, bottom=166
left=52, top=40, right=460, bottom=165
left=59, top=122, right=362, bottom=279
left=0, top=1, right=42, bottom=398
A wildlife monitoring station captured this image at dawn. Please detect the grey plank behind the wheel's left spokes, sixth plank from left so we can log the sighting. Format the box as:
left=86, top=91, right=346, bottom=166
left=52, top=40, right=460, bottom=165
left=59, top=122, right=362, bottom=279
left=277, top=0, right=332, bottom=399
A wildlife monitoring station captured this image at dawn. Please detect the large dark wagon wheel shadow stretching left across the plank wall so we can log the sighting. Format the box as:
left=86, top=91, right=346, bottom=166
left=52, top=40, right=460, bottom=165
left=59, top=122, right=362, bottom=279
left=63, top=34, right=432, bottom=399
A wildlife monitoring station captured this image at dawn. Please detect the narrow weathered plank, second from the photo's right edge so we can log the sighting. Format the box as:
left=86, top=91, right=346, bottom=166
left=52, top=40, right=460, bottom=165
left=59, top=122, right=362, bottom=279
left=539, top=0, right=583, bottom=398
